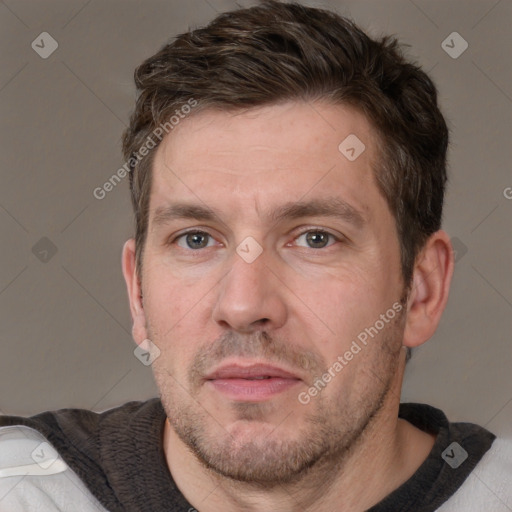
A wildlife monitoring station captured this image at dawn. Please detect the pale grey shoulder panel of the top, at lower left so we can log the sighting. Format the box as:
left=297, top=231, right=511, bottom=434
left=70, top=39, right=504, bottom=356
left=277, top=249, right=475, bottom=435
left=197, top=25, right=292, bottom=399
left=0, top=424, right=106, bottom=512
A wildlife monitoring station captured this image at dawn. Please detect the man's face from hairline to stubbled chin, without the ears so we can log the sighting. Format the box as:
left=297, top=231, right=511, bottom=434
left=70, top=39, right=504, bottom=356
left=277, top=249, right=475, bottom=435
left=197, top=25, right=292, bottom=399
left=135, top=103, right=404, bottom=485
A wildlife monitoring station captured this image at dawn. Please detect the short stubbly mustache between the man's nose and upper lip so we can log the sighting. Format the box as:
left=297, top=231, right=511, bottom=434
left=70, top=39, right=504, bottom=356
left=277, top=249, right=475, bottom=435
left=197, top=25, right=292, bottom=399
left=189, top=331, right=327, bottom=386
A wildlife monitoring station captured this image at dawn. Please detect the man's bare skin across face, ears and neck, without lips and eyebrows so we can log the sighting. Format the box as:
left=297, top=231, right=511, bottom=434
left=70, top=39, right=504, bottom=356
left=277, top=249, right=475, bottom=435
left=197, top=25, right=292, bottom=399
left=123, top=102, right=454, bottom=512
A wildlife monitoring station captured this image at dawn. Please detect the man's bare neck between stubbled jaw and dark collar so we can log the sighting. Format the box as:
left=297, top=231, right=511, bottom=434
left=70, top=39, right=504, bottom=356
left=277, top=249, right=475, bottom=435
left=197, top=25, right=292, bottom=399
left=164, top=350, right=435, bottom=512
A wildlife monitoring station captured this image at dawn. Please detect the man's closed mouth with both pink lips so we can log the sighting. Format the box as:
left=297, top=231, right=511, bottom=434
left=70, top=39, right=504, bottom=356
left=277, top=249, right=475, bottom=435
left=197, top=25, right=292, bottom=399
left=205, top=364, right=302, bottom=402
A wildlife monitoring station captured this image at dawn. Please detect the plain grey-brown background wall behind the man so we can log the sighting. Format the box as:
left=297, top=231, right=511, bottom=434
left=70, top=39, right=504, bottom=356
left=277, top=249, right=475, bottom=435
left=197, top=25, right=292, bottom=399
left=0, top=0, right=512, bottom=435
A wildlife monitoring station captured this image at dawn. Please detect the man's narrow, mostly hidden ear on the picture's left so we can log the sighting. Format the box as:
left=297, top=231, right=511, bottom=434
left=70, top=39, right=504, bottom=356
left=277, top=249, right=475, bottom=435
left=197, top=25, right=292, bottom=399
left=121, top=238, right=148, bottom=344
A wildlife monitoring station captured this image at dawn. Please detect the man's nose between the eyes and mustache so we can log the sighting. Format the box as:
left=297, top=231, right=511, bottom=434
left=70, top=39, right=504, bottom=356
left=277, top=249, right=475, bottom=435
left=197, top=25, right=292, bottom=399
left=213, top=246, right=287, bottom=334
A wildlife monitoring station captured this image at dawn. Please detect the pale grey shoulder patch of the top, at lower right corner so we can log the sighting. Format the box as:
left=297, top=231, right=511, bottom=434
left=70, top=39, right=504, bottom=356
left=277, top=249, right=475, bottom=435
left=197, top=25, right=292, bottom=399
left=438, top=438, right=512, bottom=512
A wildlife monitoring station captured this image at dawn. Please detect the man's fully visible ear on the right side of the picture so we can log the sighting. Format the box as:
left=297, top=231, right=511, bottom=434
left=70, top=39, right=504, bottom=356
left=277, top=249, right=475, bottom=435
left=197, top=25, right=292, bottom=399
left=403, top=230, right=454, bottom=347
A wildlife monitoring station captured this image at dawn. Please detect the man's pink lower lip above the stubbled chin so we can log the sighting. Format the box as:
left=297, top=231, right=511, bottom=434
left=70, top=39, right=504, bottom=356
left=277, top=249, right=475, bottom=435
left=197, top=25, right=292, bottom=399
left=208, top=377, right=300, bottom=402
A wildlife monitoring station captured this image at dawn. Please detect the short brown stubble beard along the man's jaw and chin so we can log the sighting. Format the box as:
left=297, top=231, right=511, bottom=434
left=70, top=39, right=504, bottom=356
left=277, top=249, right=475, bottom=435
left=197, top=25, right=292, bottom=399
left=153, top=318, right=403, bottom=489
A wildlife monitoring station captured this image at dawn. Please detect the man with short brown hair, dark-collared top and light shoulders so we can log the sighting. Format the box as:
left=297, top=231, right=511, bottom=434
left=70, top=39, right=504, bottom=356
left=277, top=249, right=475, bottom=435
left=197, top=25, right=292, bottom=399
left=0, top=1, right=512, bottom=512
